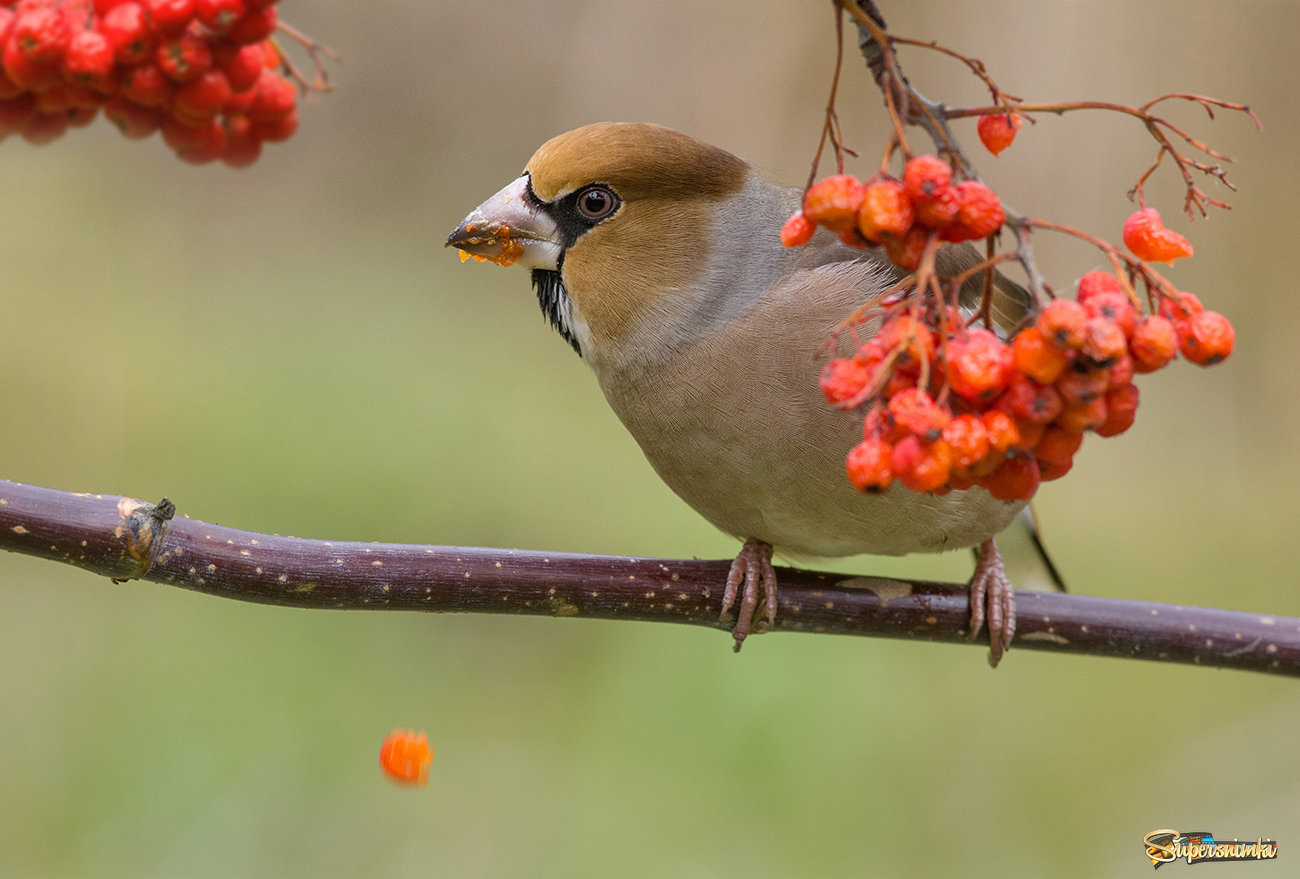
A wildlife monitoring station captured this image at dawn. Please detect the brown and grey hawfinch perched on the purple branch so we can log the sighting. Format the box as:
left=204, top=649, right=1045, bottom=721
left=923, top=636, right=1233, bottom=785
left=447, top=124, right=1028, bottom=664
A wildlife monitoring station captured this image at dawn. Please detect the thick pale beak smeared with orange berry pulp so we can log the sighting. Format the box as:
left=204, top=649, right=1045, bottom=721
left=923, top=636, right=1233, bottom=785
left=446, top=174, right=560, bottom=270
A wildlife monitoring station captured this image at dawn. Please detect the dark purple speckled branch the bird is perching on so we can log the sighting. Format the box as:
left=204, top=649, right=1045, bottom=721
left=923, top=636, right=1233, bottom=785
left=0, top=480, right=1300, bottom=676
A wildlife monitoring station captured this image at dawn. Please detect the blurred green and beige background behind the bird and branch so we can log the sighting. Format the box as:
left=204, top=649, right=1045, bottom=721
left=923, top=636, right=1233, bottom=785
left=0, top=0, right=1300, bottom=879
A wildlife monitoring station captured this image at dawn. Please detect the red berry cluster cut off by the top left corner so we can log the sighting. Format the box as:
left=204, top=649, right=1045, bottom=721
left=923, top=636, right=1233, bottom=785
left=0, top=0, right=298, bottom=166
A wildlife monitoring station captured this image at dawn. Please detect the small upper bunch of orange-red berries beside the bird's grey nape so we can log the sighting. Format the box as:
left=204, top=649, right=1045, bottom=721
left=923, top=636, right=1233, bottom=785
left=781, top=155, right=1005, bottom=269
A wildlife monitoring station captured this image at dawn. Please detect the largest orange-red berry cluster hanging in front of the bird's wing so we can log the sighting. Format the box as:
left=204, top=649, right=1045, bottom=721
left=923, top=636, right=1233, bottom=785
left=820, top=272, right=1234, bottom=501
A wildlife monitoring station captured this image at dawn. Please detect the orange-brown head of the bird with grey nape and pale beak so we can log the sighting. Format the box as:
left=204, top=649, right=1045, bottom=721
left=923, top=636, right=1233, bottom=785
left=447, top=122, right=800, bottom=365
